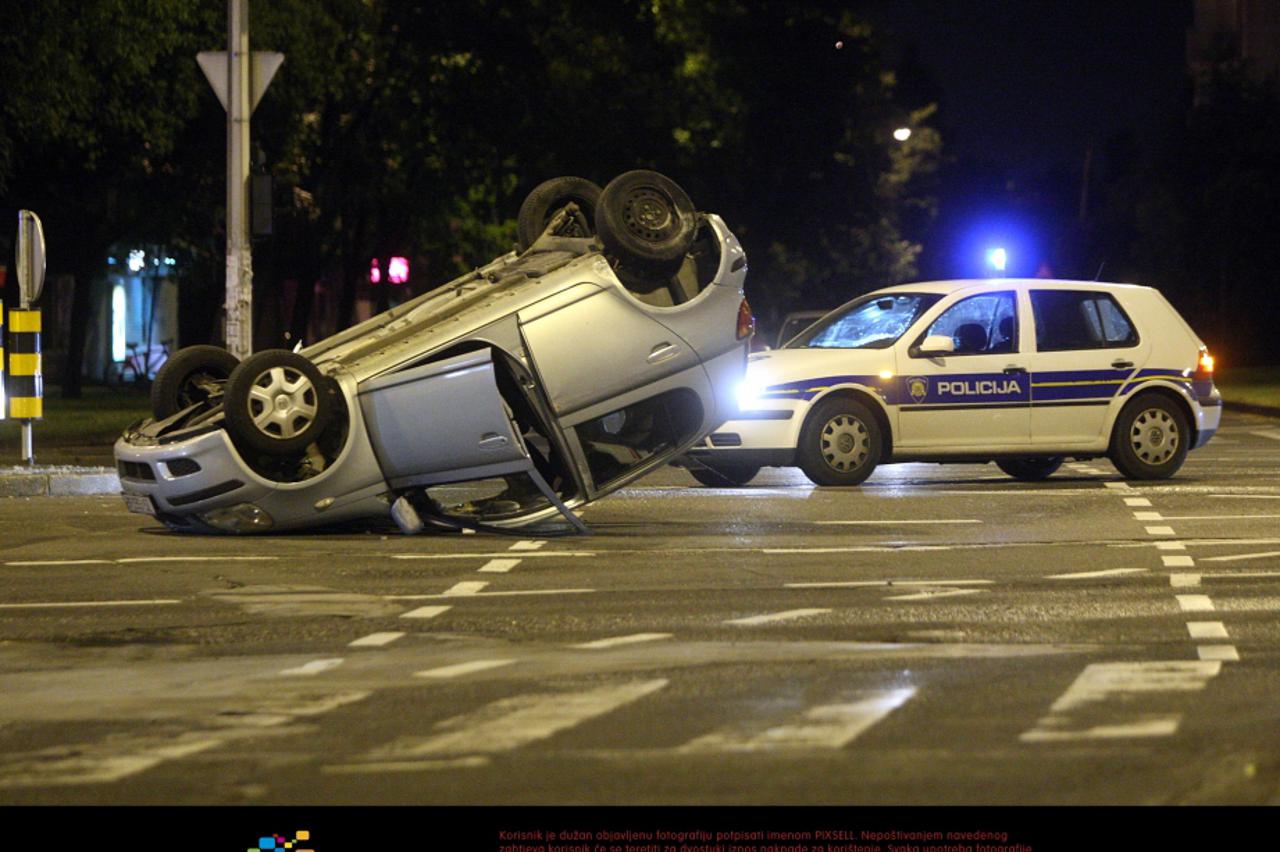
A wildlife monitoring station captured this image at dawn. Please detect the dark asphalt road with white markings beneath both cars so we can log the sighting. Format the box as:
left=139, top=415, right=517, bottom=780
left=0, top=414, right=1280, bottom=805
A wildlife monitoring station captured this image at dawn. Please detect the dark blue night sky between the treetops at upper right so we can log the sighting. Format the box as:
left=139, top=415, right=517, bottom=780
left=872, top=0, right=1193, bottom=173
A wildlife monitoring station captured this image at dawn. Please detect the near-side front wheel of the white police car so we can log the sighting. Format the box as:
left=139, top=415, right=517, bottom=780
left=796, top=397, right=882, bottom=485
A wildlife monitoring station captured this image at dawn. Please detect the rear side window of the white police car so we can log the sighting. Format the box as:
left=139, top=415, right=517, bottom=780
left=1030, top=290, right=1138, bottom=352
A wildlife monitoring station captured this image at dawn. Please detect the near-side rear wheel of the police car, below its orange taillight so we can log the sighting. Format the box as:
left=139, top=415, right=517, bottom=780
left=1108, top=393, right=1192, bottom=480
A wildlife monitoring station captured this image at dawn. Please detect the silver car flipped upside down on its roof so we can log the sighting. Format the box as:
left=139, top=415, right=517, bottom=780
left=115, top=171, right=754, bottom=533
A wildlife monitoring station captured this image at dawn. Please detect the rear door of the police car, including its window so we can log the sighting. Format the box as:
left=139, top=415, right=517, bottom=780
left=1028, top=287, right=1151, bottom=449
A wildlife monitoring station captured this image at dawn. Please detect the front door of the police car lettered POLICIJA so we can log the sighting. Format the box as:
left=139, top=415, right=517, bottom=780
left=895, top=288, right=1030, bottom=453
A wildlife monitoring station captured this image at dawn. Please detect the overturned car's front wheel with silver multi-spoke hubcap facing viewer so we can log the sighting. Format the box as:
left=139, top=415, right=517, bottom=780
left=223, top=349, right=339, bottom=455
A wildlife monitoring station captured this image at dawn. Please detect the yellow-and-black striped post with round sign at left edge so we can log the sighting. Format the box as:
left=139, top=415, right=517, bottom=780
left=6, top=210, right=45, bottom=464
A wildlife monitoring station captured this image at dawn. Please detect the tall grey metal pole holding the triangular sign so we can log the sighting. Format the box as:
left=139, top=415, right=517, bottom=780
left=225, top=0, right=253, bottom=359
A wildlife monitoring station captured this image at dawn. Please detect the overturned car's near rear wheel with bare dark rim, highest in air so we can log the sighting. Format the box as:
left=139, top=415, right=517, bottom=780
left=595, top=169, right=698, bottom=269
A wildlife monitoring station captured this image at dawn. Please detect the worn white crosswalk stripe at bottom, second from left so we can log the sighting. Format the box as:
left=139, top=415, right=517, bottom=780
left=370, top=678, right=667, bottom=760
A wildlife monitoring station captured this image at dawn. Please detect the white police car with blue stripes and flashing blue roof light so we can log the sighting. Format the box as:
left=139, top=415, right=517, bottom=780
left=685, top=279, right=1222, bottom=486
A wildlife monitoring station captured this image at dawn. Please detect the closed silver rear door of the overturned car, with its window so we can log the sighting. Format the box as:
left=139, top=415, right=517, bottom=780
left=520, top=283, right=714, bottom=495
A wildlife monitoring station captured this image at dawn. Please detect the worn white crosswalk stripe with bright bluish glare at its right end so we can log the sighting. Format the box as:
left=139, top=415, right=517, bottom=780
left=676, top=687, right=915, bottom=753
